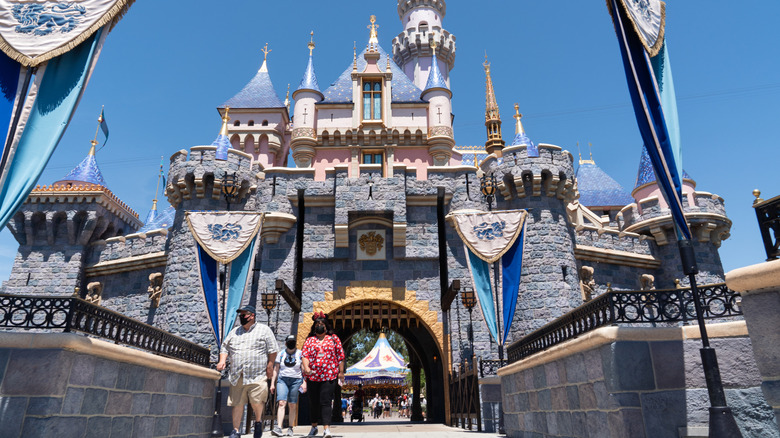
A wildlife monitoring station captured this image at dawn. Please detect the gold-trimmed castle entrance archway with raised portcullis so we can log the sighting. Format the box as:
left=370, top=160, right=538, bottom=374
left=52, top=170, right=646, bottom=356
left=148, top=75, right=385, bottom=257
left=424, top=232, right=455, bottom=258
left=298, top=282, right=449, bottom=423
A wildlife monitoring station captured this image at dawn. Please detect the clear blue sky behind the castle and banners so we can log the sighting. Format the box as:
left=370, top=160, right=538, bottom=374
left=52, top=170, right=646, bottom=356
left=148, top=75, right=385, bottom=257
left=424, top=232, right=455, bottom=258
left=0, top=0, right=780, bottom=281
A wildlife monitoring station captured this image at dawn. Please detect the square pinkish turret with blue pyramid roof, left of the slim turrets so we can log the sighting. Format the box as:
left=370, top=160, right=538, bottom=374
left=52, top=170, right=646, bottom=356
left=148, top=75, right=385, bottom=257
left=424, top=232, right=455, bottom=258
left=217, top=44, right=290, bottom=167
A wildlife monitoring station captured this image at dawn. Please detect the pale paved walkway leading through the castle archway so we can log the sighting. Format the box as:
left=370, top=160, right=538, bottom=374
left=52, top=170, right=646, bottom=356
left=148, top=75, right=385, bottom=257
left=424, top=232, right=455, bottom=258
left=235, top=419, right=504, bottom=438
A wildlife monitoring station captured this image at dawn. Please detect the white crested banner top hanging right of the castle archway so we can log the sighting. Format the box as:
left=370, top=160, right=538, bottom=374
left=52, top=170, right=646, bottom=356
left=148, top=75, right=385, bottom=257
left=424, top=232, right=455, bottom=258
left=451, top=210, right=528, bottom=263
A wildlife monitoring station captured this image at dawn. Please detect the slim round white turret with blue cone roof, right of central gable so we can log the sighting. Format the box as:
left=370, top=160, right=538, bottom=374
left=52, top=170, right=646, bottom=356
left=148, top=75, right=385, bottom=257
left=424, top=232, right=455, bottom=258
left=420, top=36, right=455, bottom=166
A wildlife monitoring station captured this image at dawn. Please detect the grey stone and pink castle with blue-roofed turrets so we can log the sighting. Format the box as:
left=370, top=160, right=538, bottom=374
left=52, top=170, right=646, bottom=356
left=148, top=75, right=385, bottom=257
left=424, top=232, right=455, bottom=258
left=2, top=0, right=756, bottom=432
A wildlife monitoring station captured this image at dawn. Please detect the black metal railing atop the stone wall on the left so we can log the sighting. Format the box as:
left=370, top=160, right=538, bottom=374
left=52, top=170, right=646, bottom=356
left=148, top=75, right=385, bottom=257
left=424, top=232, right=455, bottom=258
left=0, top=294, right=209, bottom=367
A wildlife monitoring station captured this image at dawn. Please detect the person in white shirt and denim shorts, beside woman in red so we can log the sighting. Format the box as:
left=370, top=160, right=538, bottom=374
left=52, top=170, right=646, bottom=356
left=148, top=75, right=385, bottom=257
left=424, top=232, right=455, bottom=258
left=271, top=335, right=306, bottom=436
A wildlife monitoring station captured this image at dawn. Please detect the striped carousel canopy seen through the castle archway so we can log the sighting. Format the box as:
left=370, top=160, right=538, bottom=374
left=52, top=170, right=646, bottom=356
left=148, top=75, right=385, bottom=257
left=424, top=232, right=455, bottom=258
left=345, top=333, right=409, bottom=389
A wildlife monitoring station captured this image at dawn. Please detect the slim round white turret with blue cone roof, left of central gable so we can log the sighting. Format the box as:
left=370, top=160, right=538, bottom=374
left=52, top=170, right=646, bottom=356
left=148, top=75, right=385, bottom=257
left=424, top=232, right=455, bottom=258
left=291, top=32, right=324, bottom=167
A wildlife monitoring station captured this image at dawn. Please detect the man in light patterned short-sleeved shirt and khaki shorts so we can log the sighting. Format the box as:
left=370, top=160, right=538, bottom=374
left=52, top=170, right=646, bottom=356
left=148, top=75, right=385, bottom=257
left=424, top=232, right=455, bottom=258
left=217, top=306, right=279, bottom=438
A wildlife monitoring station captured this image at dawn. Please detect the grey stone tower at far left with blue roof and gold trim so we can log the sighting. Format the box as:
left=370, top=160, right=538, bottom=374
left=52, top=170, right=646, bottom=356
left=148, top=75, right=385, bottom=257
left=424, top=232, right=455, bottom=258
left=4, top=116, right=142, bottom=296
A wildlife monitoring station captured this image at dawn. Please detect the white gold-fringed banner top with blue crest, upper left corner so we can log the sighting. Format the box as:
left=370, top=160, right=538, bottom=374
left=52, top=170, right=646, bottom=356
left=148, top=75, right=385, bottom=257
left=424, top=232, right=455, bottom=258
left=0, top=0, right=135, bottom=66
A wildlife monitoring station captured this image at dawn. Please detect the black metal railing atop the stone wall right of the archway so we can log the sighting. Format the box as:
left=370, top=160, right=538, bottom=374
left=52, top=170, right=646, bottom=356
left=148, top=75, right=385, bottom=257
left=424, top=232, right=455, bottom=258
left=507, top=283, right=742, bottom=363
